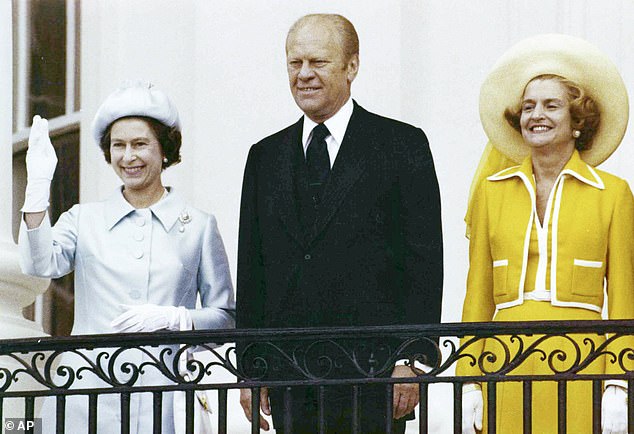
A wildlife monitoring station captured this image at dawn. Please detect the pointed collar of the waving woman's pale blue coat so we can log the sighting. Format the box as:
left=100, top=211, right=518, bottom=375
left=104, top=187, right=189, bottom=232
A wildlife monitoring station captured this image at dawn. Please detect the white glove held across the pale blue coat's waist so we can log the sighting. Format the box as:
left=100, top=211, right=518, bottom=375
left=110, top=304, right=192, bottom=333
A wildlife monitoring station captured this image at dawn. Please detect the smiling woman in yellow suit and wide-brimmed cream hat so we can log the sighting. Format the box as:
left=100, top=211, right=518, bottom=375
left=457, top=34, right=634, bottom=434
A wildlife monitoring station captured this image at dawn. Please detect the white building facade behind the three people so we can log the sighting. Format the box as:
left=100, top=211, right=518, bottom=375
left=0, top=0, right=634, bottom=432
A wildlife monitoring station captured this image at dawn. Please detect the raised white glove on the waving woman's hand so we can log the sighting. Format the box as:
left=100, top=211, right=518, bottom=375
left=22, top=115, right=57, bottom=212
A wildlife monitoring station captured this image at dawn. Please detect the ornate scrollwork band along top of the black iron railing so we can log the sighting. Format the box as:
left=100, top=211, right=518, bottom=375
left=0, top=320, right=634, bottom=396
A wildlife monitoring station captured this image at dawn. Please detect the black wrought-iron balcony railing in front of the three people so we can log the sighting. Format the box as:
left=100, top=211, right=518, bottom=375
left=0, top=320, right=634, bottom=433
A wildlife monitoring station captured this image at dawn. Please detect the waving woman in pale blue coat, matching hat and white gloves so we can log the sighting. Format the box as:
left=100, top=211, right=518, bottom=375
left=19, top=82, right=235, bottom=434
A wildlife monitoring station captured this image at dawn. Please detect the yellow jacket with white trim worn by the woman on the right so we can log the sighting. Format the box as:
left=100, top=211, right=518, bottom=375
left=462, top=151, right=634, bottom=322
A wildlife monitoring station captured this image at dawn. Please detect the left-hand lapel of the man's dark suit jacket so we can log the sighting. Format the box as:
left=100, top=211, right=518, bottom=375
left=274, top=118, right=305, bottom=246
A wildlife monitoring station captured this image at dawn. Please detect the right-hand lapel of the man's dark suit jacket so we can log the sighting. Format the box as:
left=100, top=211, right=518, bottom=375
left=309, top=102, right=371, bottom=241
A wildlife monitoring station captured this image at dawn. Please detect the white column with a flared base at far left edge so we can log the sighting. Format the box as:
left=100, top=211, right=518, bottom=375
left=0, top=0, right=48, bottom=417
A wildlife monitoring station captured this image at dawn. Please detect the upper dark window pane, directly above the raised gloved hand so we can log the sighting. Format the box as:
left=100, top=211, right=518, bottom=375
left=29, top=0, right=66, bottom=118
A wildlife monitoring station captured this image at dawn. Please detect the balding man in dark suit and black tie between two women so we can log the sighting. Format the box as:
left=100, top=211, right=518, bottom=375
left=237, top=14, right=442, bottom=433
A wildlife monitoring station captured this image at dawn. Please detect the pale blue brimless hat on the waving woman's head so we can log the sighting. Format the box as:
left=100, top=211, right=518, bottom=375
left=92, top=80, right=180, bottom=145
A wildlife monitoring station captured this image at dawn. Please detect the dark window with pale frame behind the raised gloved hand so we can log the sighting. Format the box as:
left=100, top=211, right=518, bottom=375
left=13, top=0, right=80, bottom=336
